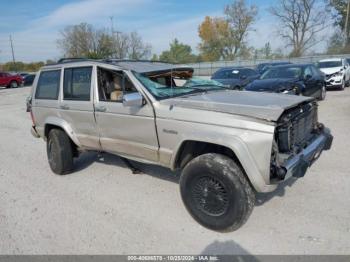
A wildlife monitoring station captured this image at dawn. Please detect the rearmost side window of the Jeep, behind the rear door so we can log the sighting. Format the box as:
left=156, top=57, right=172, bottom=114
left=35, top=70, right=61, bottom=100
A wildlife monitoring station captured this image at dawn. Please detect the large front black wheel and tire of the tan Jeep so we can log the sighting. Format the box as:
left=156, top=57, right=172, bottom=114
left=180, top=153, right=255, bottom=232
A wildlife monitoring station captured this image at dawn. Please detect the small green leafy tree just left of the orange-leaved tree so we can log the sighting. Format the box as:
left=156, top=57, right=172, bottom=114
left=159, top=38, right=197, bottom=63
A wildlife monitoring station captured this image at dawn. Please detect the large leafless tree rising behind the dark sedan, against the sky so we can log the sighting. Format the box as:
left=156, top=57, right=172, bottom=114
left=270, top=0, right=329, bottom=57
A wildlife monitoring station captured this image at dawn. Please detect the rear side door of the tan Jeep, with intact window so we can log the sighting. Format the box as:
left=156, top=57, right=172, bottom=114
left=59, top=66, right=100, bottom=149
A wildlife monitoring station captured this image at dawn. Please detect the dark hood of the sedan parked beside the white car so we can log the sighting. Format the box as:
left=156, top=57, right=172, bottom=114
left=245, top=78, right=297, bottom=92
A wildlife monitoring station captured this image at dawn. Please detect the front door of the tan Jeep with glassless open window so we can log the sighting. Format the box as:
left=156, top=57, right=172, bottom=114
left=95, top=67, right=159, bottom=162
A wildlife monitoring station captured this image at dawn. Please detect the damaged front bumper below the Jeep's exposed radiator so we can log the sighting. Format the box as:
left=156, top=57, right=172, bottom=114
left=282, top=127, right=333, bottom=180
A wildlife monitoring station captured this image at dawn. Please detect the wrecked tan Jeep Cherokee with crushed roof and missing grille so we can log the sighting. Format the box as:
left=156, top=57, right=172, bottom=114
left=27, top=59, right=333, bottom=231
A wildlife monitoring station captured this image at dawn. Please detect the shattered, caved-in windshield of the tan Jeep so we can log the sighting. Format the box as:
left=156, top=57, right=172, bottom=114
left=134, top=72, right=227, bottom=99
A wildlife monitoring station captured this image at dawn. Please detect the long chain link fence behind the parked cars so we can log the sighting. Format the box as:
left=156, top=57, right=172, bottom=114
left=187, top=54, right=350, bottom=76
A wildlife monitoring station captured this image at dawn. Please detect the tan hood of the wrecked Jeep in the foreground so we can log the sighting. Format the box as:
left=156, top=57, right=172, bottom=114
left=160, top=90, right=313, bottom=121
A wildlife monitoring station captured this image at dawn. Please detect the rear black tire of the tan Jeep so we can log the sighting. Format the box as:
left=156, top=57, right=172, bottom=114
left=46, top=129, right=74, bottom=175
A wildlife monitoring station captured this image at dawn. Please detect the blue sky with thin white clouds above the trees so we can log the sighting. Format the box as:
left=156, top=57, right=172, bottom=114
left=0, top=0, right=330, bottom=63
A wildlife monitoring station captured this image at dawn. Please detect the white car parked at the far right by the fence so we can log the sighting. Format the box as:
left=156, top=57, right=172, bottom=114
left=317, top=58, right=350, bottom=90
